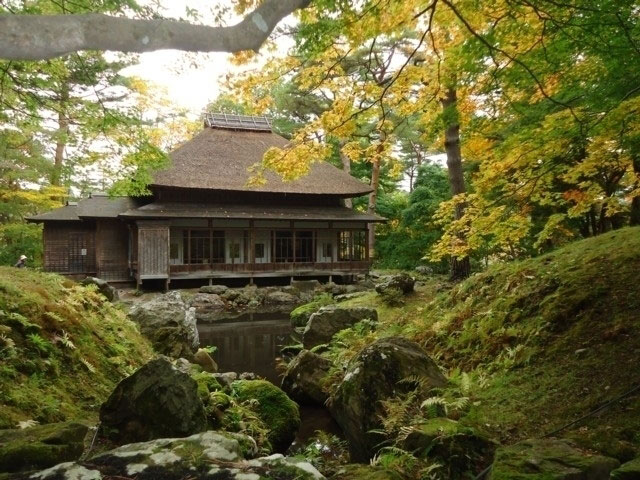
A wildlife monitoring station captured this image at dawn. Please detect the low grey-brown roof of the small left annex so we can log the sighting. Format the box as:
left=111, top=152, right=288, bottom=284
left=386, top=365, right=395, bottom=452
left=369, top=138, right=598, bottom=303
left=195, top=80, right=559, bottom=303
left=27, top=193, right=139, bottom=223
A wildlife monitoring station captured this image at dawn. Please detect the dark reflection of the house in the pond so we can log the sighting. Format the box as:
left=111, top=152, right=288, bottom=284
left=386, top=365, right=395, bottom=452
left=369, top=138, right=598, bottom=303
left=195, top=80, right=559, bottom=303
left=198, top=318, right=292, bottom=383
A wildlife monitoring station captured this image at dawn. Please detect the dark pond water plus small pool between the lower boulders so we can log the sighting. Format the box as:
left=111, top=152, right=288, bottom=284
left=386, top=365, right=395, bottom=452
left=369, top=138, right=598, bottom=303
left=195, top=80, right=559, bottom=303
left=198, top=313, right=342, bottom=451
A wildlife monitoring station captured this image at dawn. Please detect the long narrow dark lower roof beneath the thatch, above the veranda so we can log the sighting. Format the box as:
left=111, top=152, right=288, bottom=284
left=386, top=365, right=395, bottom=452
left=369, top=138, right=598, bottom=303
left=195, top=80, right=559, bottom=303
left=120, top=202, right=385, bottom=222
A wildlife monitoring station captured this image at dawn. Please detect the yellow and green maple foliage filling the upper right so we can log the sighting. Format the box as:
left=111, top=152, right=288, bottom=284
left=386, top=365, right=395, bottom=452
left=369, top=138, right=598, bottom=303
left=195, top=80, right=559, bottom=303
left=222, top=0, right=640, bottom=278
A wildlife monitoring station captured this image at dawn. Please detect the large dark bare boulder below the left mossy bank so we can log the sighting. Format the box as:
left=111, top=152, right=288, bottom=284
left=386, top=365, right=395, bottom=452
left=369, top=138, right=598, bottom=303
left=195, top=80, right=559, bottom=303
left=100, top=358, right=207, bottom=443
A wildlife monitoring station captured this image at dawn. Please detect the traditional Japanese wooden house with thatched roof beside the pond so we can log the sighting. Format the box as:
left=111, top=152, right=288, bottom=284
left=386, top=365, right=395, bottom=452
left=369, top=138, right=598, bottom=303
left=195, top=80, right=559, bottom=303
left=29, top=114, right=384, bottom=285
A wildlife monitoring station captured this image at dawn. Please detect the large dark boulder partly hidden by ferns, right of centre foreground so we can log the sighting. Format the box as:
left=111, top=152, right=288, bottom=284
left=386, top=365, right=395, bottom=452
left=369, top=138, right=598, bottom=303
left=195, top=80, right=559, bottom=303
left=331, top=337, right=447, bottom=462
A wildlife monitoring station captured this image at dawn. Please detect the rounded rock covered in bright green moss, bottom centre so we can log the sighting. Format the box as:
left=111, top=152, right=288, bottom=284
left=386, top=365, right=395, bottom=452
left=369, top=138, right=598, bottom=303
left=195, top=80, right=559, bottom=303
left=231, top=380, right=300, bottom=452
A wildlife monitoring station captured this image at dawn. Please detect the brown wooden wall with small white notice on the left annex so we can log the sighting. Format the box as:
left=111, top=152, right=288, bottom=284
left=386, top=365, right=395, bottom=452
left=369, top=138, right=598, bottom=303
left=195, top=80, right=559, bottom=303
left=43, top=222, right=96, bottom=275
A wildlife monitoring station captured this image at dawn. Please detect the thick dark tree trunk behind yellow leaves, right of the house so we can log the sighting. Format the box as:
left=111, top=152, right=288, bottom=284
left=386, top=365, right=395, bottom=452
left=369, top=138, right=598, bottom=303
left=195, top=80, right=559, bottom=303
left=441, top=88, right=471, bottom=281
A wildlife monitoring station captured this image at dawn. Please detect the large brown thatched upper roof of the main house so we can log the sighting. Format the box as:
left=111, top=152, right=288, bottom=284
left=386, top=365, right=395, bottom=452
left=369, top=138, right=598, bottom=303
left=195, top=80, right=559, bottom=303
left=152, top=127, right=371, bottom=197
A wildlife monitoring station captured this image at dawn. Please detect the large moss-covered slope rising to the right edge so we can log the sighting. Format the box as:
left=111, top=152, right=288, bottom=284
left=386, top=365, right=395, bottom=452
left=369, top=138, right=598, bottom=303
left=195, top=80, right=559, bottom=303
left=330, top=227, right=640, bottom=461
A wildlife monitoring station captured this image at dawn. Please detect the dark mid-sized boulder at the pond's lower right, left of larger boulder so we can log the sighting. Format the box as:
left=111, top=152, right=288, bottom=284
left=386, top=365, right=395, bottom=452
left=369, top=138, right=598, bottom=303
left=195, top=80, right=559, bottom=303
left=282, top=350, right=331, bottom=405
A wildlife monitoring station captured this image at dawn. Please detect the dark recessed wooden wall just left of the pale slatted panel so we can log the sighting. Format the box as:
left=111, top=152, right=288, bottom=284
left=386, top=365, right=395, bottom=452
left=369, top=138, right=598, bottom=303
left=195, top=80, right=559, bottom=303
left=96, top=219, right=130, bottom=281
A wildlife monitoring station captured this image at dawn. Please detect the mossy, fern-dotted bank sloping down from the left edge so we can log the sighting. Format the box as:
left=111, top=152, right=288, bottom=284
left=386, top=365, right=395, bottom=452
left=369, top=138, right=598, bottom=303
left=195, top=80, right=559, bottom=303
left=0, top=267, right=152, bottom=428
